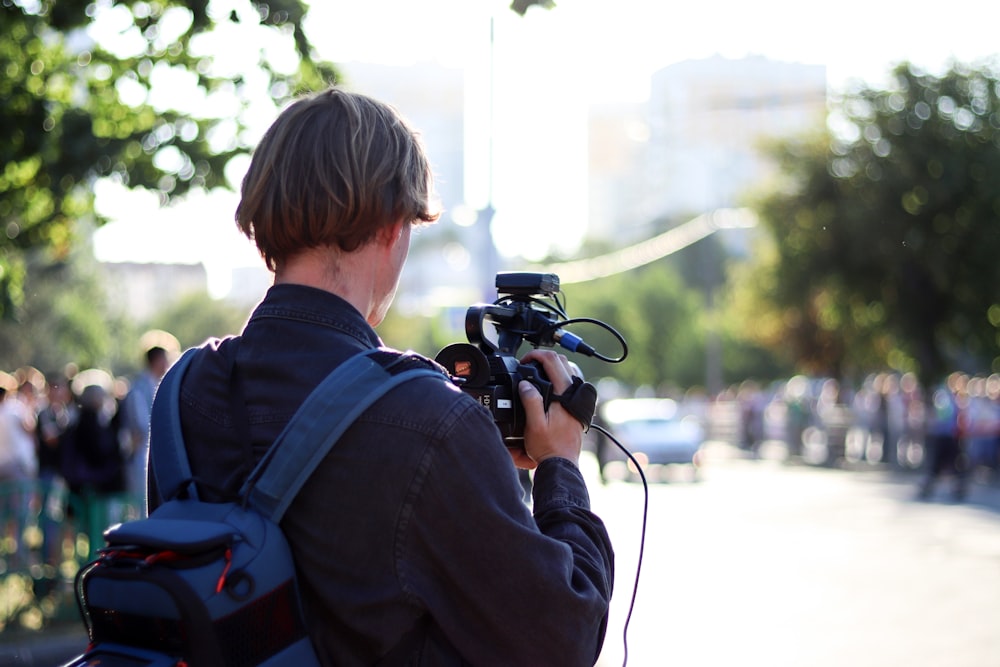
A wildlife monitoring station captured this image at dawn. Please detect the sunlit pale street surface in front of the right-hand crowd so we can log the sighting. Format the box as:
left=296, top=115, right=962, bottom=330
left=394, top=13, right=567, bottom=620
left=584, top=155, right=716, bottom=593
left=584, top=445, right=1000, bottom=667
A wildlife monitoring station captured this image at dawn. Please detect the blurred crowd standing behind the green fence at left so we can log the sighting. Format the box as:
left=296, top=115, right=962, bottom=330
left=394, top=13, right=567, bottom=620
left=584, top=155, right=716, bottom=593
left=0, top=347, right=168, bottom=569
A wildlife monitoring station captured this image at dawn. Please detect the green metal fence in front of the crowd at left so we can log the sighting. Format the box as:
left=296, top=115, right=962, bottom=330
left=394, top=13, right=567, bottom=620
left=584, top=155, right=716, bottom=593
left=0, top=480, right=142, bottom=641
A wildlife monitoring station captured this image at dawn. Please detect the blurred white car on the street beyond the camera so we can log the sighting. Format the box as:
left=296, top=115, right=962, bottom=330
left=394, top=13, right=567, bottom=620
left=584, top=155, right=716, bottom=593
left=597, top=398, right=705, bottom=479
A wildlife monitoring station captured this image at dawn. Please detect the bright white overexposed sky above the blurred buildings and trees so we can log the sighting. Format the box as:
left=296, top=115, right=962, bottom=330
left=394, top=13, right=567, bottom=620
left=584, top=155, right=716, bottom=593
left=95, top=0, right=1000, bottom=294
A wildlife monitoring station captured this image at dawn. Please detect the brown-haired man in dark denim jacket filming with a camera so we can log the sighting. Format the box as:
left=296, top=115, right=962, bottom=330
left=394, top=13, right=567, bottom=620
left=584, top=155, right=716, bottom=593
left=150, top=89, right=613, bottom=666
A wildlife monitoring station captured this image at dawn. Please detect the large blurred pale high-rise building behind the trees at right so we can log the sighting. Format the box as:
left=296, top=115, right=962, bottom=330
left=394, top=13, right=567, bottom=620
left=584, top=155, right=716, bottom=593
left=590, top=56, right=827, bottom=240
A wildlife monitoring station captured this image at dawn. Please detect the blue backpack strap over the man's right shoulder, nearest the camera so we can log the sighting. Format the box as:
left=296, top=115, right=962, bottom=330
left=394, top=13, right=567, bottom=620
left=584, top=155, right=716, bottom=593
left=240, top=348, right=447, bottom=523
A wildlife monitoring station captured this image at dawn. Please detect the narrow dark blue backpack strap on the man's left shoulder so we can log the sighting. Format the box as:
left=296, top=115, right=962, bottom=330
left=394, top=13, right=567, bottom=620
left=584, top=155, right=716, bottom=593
left=149, top=347, right=198, bottom=498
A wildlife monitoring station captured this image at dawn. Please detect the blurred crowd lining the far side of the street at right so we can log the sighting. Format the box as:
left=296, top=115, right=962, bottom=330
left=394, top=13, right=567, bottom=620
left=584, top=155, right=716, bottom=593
left=720, top=372, right=1000, bottom=494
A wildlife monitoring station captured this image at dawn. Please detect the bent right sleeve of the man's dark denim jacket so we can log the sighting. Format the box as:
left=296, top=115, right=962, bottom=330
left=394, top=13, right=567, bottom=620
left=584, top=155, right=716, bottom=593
left=400, top=405, right=614, bottom=666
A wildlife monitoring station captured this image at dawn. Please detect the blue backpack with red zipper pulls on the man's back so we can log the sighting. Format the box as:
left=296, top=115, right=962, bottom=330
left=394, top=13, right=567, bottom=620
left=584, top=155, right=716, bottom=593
left=67, top=348, right=446, bottom=667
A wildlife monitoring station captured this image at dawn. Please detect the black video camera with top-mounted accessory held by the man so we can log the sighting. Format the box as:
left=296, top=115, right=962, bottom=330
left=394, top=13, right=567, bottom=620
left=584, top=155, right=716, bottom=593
left=435, top=273, right=600, bottom=447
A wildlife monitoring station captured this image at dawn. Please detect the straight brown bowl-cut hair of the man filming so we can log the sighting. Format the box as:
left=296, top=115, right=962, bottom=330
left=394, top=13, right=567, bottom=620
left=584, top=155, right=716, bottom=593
left=236, top=88, right=440, bottom=270
